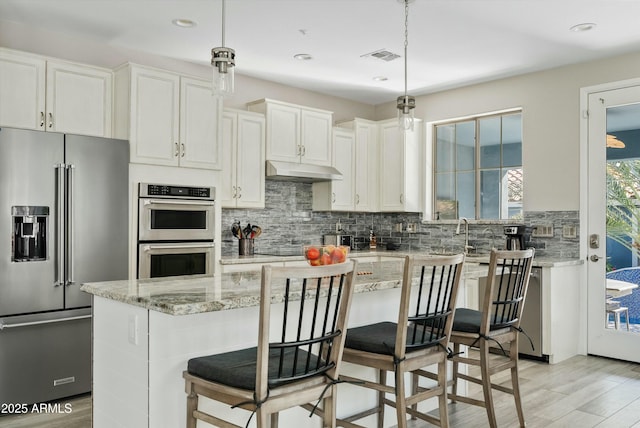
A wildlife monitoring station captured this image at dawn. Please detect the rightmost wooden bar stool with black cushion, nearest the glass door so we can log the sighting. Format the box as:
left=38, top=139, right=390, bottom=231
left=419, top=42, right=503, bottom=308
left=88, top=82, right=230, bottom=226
left=449, top=249, right=534, bottom=428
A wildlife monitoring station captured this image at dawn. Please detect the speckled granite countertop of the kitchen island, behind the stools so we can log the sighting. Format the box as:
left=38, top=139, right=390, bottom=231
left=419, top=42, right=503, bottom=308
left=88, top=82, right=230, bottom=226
left=81, top=260, right=487, bottom=315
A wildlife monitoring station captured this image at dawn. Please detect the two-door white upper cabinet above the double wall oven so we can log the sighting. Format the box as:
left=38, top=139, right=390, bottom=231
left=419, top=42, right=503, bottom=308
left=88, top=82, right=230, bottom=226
left=115, top=64, right=222, bottom=169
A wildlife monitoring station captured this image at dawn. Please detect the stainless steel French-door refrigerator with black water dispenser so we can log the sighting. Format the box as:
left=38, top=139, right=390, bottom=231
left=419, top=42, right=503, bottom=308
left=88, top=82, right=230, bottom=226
left=0, top=128, right=129, bottom=404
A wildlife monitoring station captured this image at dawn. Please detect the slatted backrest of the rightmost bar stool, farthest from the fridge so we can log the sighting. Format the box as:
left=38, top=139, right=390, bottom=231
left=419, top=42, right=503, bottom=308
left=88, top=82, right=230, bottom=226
left=480, top=249, right=534, bottom=335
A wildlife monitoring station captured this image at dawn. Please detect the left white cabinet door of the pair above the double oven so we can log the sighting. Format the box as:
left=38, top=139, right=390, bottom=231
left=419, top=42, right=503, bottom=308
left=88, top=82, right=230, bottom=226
left=129, top=66, right=180, bottom=166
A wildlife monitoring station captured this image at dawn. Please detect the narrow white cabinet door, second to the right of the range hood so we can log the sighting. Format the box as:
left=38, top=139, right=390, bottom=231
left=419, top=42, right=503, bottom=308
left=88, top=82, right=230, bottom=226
left=354, top=120, right=380, bottom=211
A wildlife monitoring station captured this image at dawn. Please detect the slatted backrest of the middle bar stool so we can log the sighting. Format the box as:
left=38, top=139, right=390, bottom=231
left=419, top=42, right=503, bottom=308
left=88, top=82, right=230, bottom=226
left=395, top=254, right=464, bottom=358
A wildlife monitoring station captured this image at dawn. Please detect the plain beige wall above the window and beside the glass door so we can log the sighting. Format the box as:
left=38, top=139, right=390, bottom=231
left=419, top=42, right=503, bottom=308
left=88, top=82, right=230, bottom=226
left=376, top=53, right=640, bottom=211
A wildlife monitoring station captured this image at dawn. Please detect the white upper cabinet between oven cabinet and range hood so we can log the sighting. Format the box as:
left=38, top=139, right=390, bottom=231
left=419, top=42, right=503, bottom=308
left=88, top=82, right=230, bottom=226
left=218, top=109, right=265, bottom=208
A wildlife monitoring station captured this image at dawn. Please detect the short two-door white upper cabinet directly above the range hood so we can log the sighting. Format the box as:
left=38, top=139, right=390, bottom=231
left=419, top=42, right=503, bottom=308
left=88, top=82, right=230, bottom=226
left=248, top=99, right=333, bottom=166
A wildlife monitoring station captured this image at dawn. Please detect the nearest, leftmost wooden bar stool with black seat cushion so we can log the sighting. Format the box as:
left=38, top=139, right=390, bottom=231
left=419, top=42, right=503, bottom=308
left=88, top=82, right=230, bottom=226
left=183, top=260, right=356, bottom=428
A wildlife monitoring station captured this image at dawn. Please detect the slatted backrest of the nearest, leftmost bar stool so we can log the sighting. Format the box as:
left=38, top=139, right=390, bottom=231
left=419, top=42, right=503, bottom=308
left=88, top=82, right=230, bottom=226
left=256, top=260, right=356, bottom=399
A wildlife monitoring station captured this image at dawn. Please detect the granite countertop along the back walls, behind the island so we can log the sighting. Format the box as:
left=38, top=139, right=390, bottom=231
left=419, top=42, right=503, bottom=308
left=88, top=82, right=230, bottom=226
left=220, top=250, right=584, bottom=267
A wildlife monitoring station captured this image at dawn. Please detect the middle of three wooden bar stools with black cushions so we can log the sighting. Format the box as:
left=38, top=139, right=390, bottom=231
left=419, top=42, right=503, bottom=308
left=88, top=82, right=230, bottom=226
left=338, top=254, right=464, bottom=428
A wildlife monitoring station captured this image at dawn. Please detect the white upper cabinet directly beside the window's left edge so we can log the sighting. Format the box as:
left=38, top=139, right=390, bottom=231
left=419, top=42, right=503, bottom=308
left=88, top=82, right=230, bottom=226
left=379, top=119, right=423, bottom=212
